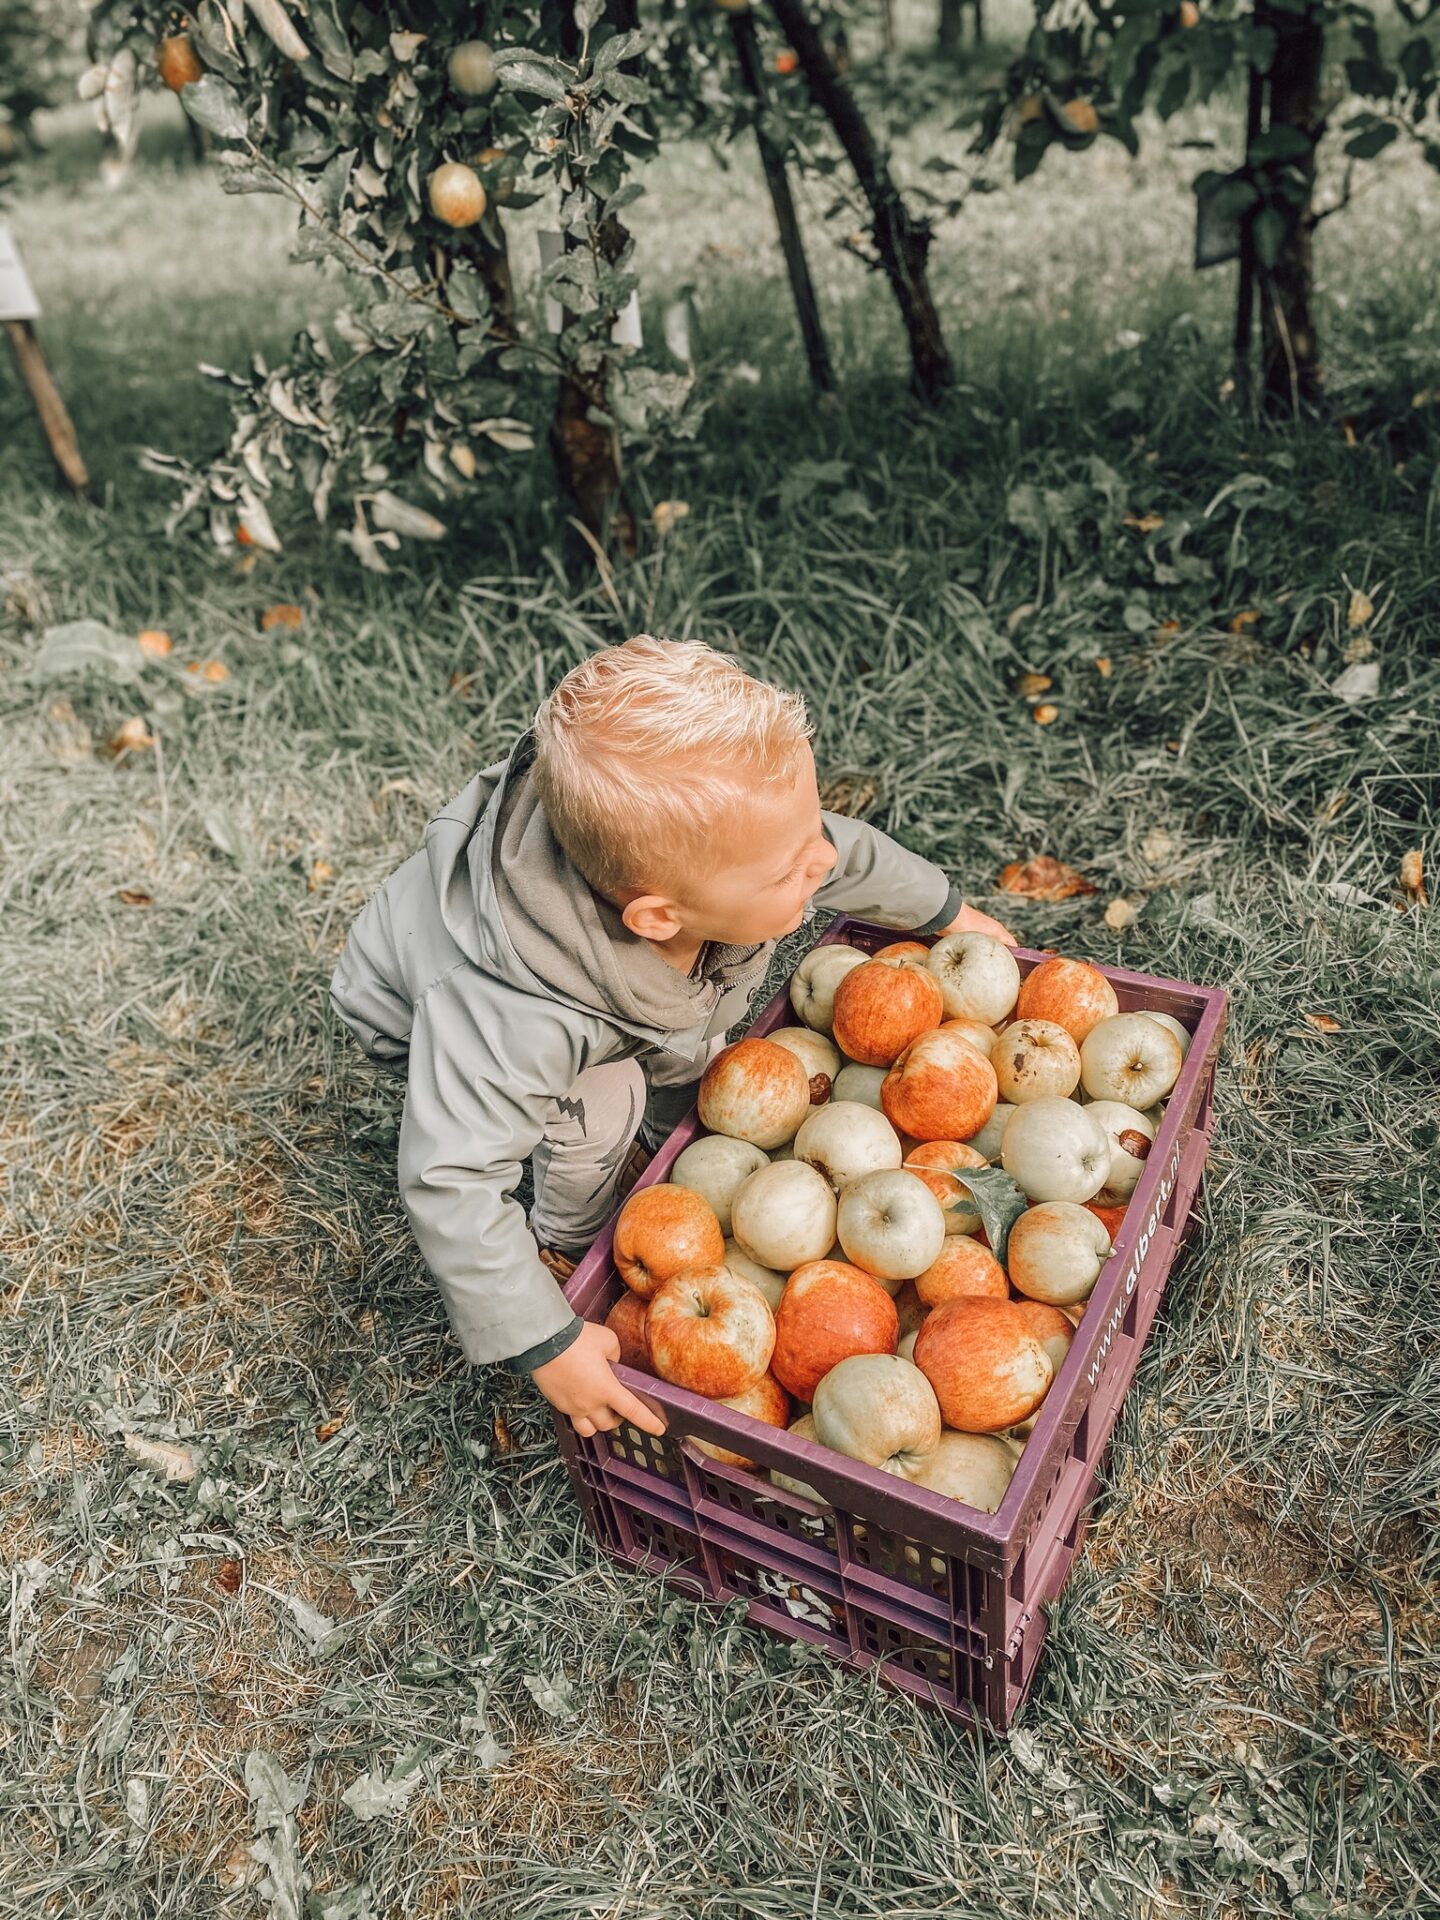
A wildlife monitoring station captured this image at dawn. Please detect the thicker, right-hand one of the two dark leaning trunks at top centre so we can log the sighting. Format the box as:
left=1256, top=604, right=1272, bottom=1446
left=774, top=0, right=954, bottom=403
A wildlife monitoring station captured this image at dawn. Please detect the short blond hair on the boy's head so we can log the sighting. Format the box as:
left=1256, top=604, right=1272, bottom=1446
left=536, top=634, right=812, bottom=895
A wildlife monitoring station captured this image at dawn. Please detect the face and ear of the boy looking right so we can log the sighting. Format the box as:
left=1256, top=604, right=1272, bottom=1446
left=624, top=747, right=835, bottom=947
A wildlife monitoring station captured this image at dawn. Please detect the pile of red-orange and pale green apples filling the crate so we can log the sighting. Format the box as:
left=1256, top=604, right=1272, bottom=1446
left=607, top=933, right=1190, bottom=1513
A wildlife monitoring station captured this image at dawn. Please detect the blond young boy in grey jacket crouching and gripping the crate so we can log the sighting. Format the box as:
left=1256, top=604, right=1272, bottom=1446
left=330, top=634, right=1010, bottom=1434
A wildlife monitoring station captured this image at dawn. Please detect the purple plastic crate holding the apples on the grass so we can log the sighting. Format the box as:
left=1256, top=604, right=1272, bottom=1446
left=555, top=918, right=1227, bottom=1730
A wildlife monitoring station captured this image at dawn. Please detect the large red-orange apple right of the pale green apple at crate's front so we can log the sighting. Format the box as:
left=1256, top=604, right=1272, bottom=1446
left=917, top=1298, right=1054, bottom=1434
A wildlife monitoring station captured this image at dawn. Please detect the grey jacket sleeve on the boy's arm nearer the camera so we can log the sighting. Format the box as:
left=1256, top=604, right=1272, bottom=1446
left=399, top=968, right=588, bottom=1373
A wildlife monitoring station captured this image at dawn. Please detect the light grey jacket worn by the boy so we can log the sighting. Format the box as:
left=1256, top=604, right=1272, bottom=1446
left=330, top=733, right=960, bottom=1373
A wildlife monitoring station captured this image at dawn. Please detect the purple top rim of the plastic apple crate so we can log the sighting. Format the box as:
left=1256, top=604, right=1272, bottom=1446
left=564, top=914, right=1229, bottom=1567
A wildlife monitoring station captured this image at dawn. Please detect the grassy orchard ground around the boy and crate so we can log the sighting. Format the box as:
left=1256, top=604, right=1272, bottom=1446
left=0, top=15, right=1440, bottom=1920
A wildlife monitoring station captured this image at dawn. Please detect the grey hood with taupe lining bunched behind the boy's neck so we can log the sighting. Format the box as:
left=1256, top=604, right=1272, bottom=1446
left=424, top=733, right=774, bottom=1058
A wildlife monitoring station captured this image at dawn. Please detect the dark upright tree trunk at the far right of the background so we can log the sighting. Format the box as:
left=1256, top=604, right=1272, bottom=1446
left=1256, top=0, right=1325, bottom=415
